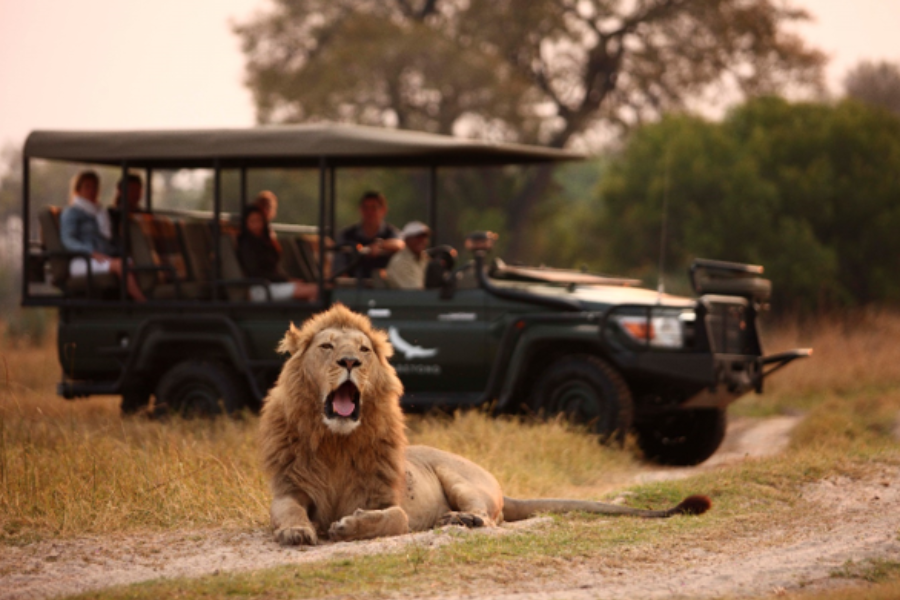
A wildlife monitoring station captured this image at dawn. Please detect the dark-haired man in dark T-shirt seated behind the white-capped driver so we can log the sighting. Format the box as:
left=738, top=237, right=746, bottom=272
left=337, top=192, right=403, bottom=277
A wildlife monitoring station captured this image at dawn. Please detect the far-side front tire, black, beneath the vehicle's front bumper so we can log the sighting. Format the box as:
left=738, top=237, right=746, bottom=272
left=635, top=408, right=727, bottom=467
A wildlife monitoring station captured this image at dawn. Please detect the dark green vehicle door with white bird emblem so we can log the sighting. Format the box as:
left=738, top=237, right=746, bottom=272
left=357, top=289, right=489, bottom=410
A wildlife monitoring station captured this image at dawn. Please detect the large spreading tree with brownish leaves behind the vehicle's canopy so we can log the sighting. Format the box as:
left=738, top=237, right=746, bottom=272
left=235, top=0, right=824, bottom=256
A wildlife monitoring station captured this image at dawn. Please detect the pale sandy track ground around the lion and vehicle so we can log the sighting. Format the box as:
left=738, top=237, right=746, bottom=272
left=0, top=417, right=900, bottom=600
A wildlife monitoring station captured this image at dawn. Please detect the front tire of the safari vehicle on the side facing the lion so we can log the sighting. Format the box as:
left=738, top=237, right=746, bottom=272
left=528, top=354, right=633, bottom=444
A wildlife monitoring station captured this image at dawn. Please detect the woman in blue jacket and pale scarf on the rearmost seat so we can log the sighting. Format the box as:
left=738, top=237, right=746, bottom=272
left=59, top=171, right=147, bottom=302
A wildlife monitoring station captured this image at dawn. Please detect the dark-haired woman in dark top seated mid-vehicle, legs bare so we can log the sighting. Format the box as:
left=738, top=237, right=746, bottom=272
left=238, top=206, right=318, bottom=302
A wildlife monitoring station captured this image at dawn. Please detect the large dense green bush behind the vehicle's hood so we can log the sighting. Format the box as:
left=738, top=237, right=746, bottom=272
left=593, top=98, right=900, bottom=310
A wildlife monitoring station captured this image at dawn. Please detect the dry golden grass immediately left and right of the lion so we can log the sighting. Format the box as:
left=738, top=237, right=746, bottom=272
left=0, top=324, right=636, bottom=543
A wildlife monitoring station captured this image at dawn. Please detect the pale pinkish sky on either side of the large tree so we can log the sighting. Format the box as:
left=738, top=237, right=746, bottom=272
left=0, top=0, right=900, bottom=151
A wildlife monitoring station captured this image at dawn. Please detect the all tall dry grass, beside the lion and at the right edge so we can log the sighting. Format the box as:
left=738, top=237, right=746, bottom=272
left=0, top=312, right=900, bottom=543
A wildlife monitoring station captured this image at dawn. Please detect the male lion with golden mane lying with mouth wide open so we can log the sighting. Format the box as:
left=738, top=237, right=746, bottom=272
left=260, top=305, right=710, bottom=545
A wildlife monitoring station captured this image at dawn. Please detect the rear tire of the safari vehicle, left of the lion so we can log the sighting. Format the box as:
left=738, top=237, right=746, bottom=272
left=154, top=360, right=244, bottom=418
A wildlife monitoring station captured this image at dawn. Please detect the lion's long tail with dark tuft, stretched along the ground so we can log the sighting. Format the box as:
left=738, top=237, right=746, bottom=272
left=503, top=496, right=712, bottom=521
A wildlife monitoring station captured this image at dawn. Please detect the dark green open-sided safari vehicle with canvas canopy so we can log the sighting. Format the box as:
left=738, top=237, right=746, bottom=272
left=22, top=125, right=807, bottom=464
